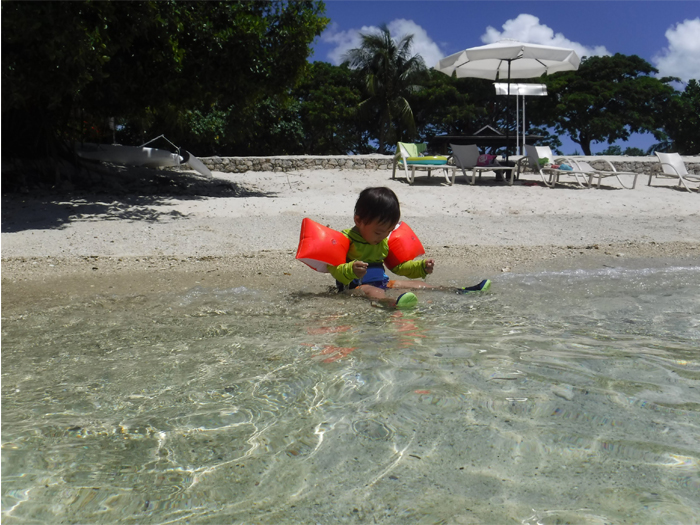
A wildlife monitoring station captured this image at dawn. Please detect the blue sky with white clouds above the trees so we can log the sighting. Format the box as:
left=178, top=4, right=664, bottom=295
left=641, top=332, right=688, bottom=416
left=311, top=0, right=700, bottom=154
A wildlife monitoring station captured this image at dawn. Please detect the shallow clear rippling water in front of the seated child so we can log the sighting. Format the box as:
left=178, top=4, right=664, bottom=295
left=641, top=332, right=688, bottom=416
left=2, top=267, right=700, bottom=524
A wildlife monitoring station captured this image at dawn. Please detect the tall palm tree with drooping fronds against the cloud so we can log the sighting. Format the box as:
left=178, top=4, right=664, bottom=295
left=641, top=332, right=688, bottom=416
left=344, top=25, right=427, bottom=153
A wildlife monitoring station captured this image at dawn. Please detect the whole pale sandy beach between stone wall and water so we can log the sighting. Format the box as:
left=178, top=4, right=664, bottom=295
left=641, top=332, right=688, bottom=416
left=2, top=169, right=700, bottom=307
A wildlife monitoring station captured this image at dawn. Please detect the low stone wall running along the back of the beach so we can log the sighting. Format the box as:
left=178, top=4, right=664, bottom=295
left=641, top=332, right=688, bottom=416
left=199, top=155, right=700, bottom=175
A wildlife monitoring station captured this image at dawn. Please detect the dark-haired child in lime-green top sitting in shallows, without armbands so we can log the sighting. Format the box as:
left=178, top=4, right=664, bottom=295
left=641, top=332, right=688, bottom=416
left=328, top=187, right=491, bottom=308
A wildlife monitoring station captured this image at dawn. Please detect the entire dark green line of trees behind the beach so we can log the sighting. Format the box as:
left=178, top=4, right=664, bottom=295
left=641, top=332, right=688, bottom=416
left=2, top=0, right=700, bottom=180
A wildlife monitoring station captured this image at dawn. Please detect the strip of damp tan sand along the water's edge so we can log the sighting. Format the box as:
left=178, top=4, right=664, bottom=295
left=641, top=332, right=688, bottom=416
left=2, top=242, right=700, bottom=311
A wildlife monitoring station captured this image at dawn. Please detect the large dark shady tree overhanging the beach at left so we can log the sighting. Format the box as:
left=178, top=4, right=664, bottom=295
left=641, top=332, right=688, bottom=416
left=2, top=0, right=328, bottom=162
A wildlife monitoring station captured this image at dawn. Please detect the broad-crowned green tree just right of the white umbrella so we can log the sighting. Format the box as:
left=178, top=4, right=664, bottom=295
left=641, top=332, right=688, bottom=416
left=528, top=54, right=674, bottom=155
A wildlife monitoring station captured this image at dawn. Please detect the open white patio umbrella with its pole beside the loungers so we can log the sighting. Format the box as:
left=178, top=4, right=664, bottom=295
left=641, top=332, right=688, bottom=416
left=435, top=40, right=581, bottom=156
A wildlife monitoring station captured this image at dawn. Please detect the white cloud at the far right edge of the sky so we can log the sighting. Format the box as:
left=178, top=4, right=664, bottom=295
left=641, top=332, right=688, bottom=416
left=651, top=18, right=700, bottom=82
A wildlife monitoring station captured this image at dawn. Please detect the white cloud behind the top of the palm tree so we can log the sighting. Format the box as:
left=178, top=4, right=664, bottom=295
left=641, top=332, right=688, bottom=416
left=321, top=18, right=445, bottom=67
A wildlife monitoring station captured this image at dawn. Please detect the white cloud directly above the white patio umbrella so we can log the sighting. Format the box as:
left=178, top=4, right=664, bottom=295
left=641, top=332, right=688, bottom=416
left=481, top=13, right=610, bottom=58
